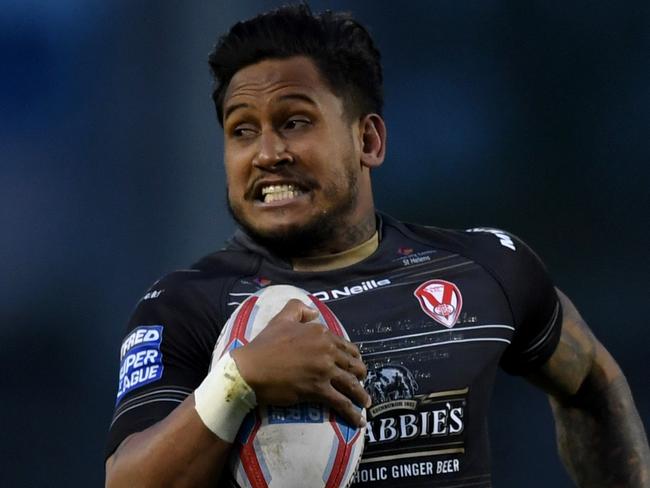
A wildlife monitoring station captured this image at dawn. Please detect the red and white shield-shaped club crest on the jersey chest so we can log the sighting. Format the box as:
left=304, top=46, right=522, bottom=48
left=413, top=280, right=463, bottom=328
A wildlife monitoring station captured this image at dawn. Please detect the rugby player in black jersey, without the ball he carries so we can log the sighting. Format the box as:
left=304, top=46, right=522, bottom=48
left=106, top=6, right=650, bottom=488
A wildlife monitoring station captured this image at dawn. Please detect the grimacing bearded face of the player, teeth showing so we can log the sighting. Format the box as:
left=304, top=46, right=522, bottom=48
left=224, top=57, right=372, bottom=256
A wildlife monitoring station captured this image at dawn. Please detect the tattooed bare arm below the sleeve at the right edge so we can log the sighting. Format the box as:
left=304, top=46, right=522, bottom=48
left=528, top=291, right=650, bottom=488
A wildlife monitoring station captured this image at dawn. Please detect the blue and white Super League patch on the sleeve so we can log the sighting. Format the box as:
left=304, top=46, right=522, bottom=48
left=116, top=325, right=163, bottom=403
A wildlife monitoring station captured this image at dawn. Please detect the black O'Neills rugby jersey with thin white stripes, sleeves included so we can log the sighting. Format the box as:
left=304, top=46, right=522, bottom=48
left=107, top=214, right=562, bottom=488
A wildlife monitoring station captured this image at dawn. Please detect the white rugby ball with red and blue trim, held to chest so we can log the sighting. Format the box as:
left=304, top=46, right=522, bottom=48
left=211, top=285, right=366, bottom=488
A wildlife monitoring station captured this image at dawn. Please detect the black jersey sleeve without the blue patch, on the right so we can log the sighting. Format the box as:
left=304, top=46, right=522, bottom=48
left=464, top=229, right=562, bottom=375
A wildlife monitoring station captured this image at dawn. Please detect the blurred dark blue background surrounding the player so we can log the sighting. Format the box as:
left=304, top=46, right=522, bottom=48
left=0, top=0, right=650, bottom=487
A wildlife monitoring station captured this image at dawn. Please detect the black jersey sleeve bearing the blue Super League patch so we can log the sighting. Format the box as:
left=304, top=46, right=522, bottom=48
left=106, top=271, right=221, bottom=457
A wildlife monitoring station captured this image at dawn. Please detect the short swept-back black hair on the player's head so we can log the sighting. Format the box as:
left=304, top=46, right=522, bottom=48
left=208, top=5, right=384, bottom=125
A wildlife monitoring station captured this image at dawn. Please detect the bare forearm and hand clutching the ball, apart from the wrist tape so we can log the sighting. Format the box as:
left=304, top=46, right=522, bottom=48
left=106, top=300, right=370, bottom=487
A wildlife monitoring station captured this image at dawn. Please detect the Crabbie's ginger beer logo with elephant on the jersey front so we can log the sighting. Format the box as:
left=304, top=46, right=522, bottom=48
left=353, top=370, right=469, bottom=486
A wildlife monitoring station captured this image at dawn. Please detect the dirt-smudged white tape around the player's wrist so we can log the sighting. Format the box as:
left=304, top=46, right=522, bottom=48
left=194, top=353, right=257, bottom=442
